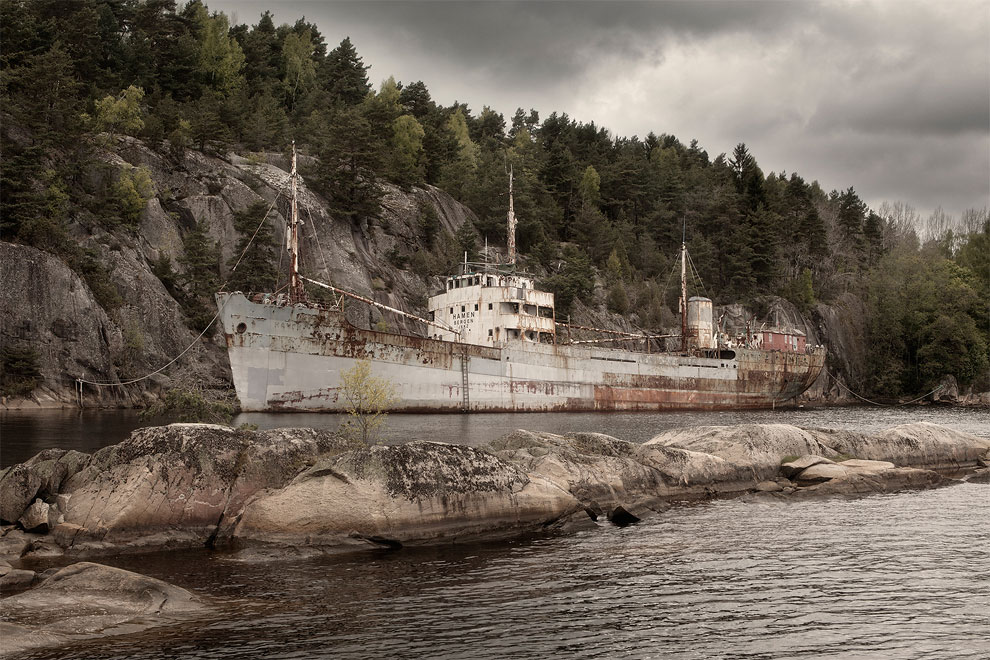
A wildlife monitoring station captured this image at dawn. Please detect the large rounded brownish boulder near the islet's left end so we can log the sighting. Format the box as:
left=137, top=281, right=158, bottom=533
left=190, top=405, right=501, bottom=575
left=52, top=424, right=348, bottom=552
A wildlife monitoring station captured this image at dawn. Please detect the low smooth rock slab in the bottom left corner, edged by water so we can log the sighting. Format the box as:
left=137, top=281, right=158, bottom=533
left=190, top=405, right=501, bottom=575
left=0, top=562, right=205, bottom=654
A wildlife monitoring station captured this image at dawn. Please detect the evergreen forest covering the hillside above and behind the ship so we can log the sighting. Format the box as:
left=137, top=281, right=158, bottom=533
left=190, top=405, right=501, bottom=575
left=0, top=0, right=990, bottom=397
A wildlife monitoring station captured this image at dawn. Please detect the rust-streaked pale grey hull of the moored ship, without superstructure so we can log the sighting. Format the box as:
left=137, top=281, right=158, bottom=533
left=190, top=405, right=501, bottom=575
left=217, top=293, right=825, bottom=412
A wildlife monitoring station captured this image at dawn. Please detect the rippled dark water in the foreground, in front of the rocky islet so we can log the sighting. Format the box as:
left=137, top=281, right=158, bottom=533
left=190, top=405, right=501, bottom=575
left=13, top=484, right=990, bottom=660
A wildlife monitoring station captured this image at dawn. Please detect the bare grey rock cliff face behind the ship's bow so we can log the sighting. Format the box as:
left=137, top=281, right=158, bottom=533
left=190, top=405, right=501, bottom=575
left=0, top=137, right=480, bottom=408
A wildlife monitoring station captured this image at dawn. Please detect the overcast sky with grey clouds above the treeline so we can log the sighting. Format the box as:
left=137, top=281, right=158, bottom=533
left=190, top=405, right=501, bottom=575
left=213, top=0, right=990, bottom=222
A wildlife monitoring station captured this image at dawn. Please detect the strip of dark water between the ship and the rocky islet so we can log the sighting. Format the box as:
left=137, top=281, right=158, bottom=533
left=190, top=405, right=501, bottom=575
left=0, top=406, right=990, bottom=467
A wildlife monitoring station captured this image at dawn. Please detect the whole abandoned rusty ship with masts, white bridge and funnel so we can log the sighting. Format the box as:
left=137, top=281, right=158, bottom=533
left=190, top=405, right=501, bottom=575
left=217, top=152, right=825, bottom=412
